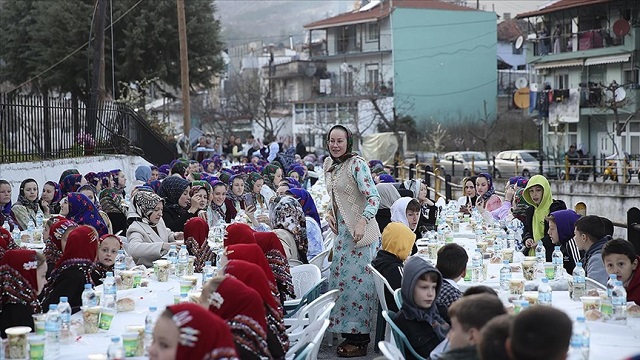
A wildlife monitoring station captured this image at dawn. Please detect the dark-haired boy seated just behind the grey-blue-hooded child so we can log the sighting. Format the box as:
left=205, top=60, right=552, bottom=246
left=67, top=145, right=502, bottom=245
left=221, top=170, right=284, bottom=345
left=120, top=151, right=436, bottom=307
left=436, top=243, right=469, bottom=323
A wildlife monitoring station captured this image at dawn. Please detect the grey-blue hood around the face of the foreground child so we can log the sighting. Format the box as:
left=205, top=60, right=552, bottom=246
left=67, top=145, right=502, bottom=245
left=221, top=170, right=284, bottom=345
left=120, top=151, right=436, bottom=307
left=400, top=256, right=449, bottom=340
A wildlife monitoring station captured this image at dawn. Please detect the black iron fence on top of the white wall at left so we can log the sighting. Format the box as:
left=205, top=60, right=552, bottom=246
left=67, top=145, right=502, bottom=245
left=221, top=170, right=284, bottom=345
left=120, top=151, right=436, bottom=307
left=0, top=94, right=177, bottom=164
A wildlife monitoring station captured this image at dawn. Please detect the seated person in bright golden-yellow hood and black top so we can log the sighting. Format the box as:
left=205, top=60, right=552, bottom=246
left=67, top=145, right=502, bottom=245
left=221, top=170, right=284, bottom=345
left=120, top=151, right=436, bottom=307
left=371, top=222, right=416, bottom=312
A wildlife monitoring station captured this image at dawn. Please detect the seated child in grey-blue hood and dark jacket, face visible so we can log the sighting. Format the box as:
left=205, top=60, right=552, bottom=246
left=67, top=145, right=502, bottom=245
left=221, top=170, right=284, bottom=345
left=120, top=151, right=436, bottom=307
left=394, top=257, right=449, bottom=360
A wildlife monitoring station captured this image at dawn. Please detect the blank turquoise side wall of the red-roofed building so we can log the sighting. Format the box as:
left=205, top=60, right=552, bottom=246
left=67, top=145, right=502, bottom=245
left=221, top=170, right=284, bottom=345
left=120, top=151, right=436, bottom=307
left=392, top=8, right=497, bottom=122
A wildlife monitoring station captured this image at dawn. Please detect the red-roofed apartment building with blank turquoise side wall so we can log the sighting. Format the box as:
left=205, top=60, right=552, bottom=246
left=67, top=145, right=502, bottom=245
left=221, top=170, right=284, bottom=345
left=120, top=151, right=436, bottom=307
left=295, top=0, right=497, bottom=148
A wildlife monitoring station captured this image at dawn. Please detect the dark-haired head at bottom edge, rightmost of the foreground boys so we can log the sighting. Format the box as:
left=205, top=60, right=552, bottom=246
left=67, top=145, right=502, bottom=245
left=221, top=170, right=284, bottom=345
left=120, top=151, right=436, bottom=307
left=506, top=306, right=572, bottom=360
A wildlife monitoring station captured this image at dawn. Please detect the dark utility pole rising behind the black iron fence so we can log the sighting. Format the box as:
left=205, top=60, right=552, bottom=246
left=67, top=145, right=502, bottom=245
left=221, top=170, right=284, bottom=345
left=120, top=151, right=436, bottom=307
left=87, top=0, right=107, bottom=139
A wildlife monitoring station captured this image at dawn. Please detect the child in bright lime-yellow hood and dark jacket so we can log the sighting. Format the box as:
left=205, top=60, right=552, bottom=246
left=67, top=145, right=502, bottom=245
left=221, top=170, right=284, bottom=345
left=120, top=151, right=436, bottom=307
left=522, top=175, right=567, bottom=262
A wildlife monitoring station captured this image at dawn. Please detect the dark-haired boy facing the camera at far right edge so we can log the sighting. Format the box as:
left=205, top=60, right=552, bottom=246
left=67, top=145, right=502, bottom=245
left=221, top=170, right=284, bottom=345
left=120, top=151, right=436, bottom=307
left=602, top=239, right=640, bottom=305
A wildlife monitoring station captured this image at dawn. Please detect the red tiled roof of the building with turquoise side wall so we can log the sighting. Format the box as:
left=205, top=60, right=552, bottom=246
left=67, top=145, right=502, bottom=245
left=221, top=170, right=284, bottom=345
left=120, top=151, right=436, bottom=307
left=304, top=0, right=478, bottom=29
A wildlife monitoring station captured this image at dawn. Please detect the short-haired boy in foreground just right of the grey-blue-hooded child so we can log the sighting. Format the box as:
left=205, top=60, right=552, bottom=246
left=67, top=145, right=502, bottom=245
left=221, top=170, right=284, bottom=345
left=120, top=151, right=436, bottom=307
left=441, top=294, right=507, bottom=360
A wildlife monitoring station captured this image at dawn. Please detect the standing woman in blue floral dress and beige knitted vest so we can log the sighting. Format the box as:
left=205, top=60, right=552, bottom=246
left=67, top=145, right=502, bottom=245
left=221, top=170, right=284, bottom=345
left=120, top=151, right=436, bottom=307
left=323, top=125, right=380, bottom=357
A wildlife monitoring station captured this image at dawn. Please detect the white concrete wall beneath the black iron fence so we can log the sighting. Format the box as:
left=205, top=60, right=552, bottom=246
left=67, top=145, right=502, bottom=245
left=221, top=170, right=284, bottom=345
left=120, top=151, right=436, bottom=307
left=0, top=155, right=150, bottom=202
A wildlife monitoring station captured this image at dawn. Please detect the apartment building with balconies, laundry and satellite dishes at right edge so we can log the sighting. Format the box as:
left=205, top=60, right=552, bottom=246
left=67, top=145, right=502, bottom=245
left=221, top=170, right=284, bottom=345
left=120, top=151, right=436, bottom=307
left=517, top=0, right=640, bottom=157
